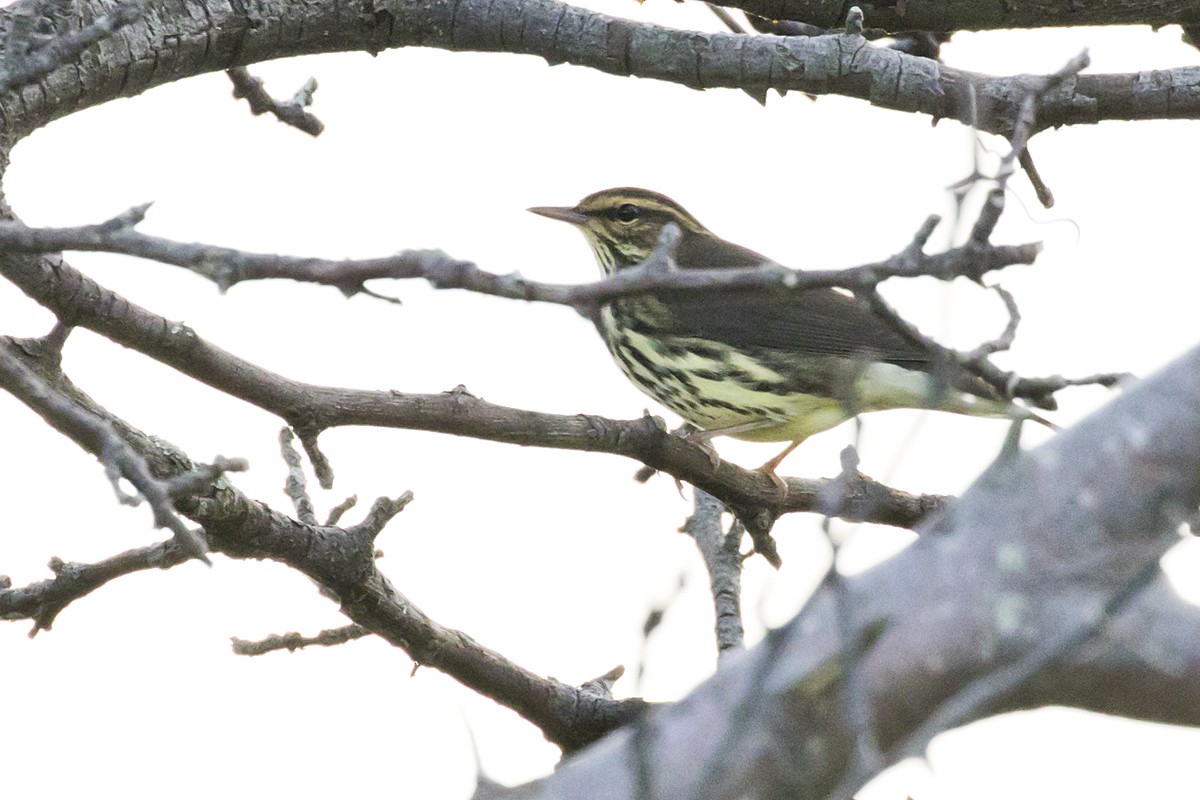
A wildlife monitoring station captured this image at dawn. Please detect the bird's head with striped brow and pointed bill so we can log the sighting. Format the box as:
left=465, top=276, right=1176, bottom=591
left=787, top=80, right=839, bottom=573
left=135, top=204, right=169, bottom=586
left=529, top=188, right=713, bottom=275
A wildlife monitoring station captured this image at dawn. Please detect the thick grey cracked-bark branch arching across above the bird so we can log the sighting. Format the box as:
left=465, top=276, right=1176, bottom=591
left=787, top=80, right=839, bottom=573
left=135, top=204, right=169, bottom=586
left=0, top=0, right=1200, bottom=146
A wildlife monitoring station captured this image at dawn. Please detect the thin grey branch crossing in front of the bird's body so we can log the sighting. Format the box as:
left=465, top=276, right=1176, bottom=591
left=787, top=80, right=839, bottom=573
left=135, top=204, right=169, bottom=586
left=0, top=205, right=1124, bottom=412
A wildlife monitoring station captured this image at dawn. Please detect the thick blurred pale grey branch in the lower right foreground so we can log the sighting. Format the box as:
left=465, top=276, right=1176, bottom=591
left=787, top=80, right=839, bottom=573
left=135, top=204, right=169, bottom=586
left=513, top=340, right=1200, bottom=799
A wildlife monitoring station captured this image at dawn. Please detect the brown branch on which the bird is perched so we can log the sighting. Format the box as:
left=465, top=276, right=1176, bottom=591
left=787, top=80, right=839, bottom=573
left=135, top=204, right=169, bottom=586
left=0, top=253, right=946, bottom=529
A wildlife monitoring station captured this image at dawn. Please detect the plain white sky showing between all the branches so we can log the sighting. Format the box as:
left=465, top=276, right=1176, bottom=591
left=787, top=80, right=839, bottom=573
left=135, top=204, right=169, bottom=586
left=0, top=0, right=1200, bottom=800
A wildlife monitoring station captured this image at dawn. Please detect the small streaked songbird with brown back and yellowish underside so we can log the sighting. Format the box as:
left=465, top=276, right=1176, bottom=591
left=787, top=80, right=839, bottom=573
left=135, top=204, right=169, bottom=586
left=529, top=188, right=1052, bottom=482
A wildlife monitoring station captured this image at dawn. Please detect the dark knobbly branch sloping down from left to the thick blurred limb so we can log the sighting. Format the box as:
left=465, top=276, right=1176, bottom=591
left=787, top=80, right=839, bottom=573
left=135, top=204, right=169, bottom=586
left=0, top=343, right=644, bottom=750
